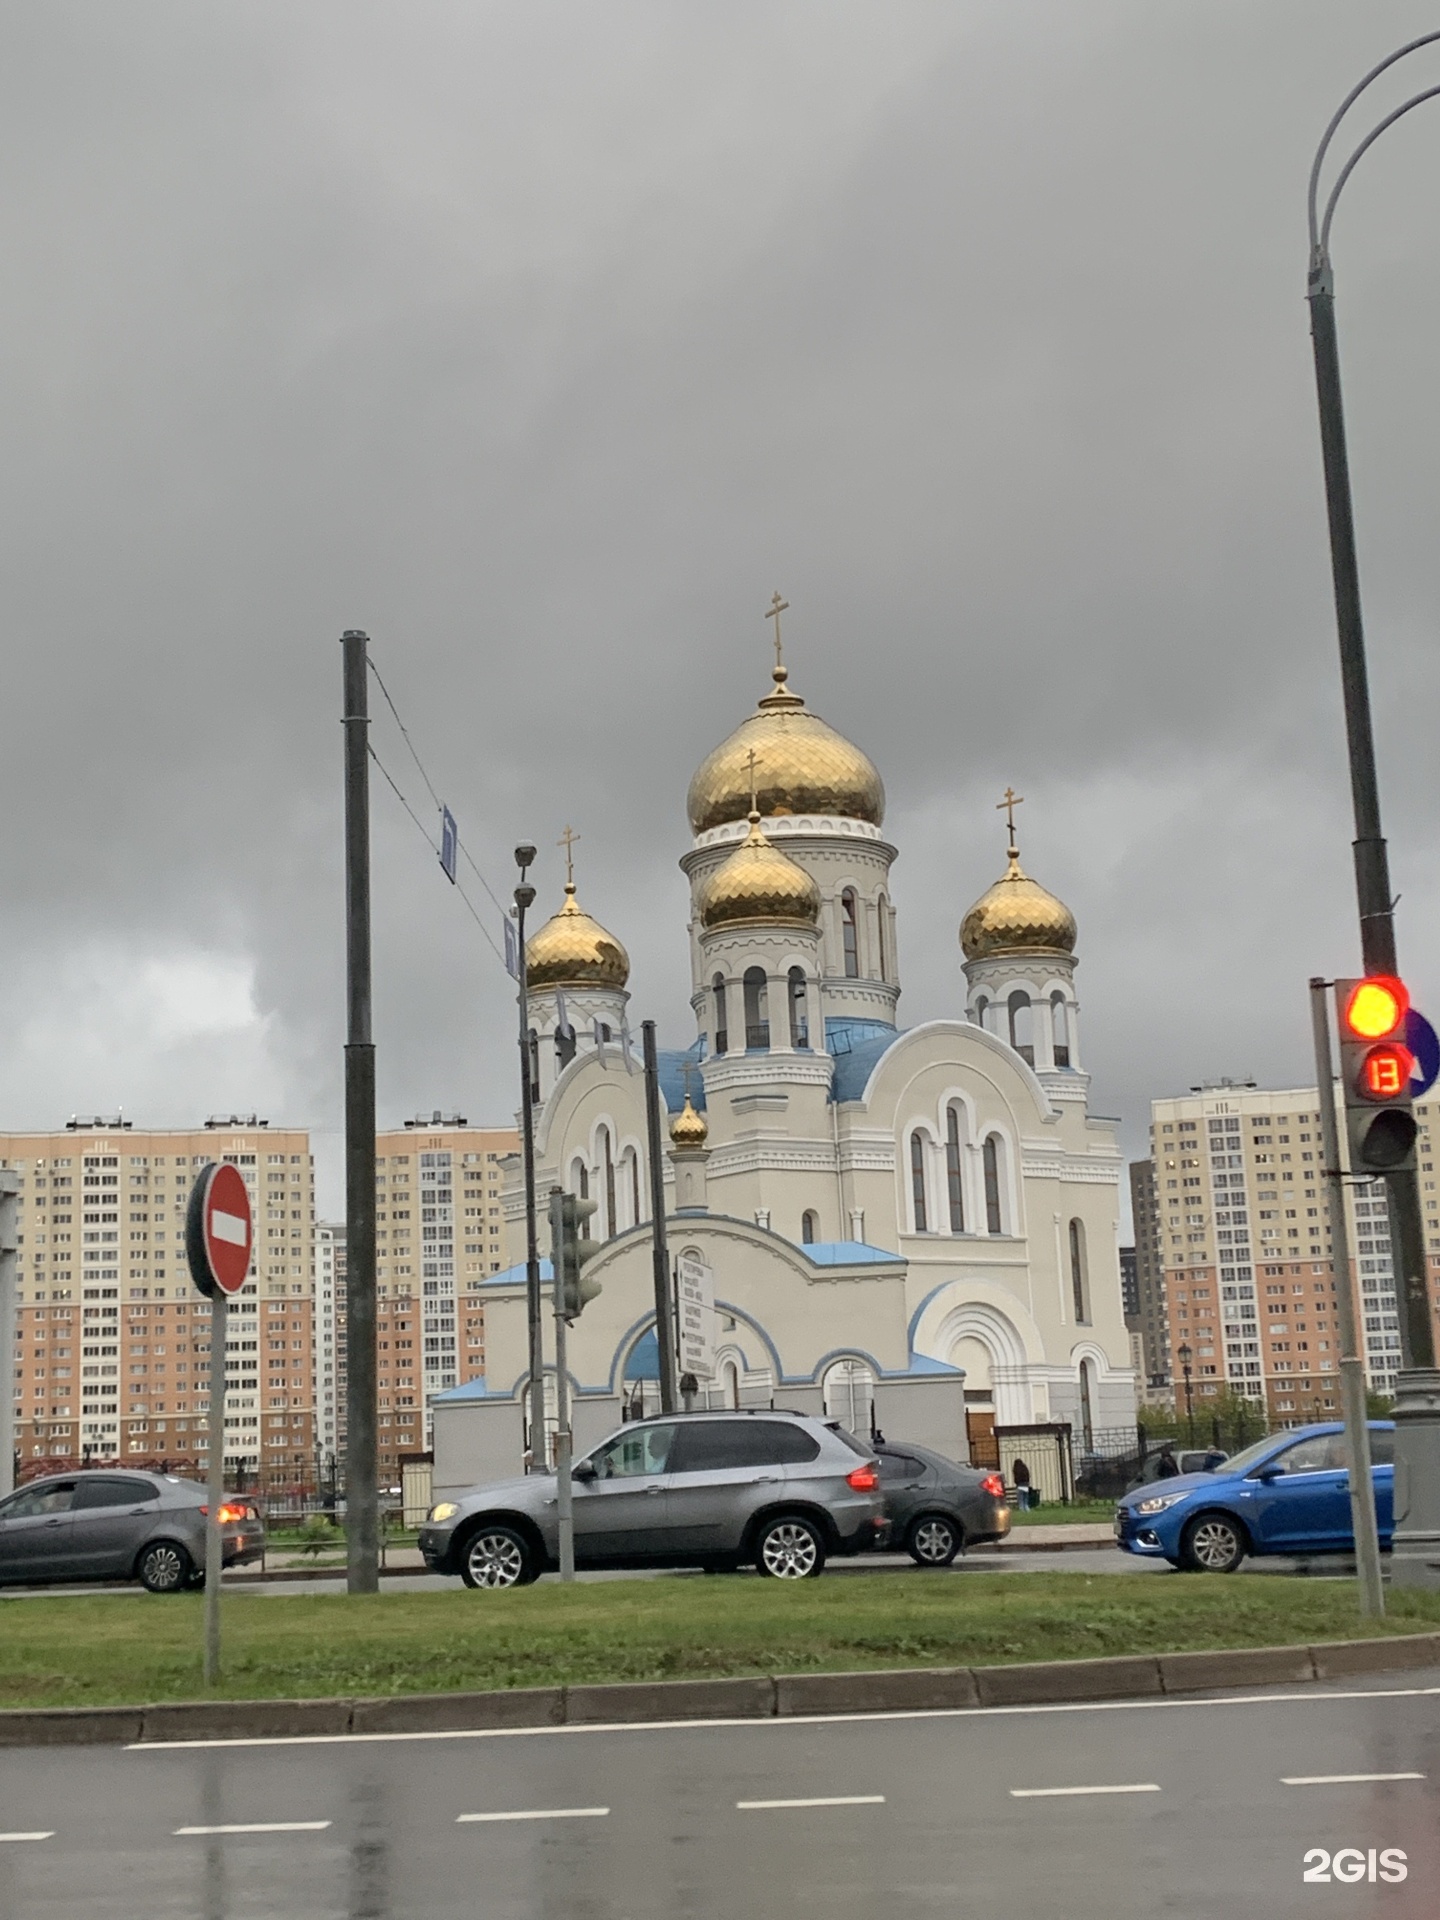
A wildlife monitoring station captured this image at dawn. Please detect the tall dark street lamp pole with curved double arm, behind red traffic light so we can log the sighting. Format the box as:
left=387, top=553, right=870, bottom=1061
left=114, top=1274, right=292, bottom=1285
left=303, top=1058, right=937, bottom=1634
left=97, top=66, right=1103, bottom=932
left=1308, top=33, right=1440, bottom=1588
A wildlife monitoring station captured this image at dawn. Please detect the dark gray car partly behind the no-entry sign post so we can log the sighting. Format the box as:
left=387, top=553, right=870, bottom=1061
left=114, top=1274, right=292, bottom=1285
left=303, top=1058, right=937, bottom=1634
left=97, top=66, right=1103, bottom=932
left=0, top=1467, right=265, bottom=1594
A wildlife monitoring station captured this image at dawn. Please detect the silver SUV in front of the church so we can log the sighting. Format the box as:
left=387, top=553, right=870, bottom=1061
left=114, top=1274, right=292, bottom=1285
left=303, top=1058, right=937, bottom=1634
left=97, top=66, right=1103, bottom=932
left=420, top=1409, right=885, bottom=1586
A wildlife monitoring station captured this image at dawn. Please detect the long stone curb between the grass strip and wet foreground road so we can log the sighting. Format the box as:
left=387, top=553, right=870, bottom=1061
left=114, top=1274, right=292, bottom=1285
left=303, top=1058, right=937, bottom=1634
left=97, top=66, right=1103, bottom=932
left=0, top=1634, right=1440, bottom=1747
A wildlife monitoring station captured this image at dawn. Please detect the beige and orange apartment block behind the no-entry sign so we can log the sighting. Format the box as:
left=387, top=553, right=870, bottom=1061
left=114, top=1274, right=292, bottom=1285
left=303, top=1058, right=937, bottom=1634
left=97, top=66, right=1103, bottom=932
left=0, top=1114, right=315, bottom=1488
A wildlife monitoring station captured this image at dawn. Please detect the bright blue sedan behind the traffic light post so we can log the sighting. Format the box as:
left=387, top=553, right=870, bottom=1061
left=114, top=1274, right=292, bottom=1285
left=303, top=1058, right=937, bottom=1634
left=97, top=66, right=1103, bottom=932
left=1116, top=1421, right=1396, bottom=1572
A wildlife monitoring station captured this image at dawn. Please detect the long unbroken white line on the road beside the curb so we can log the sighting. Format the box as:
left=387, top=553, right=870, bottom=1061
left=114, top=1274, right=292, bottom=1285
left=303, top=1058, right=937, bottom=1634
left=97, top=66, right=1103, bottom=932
left=125, top=1686, right=1440, bottom=1753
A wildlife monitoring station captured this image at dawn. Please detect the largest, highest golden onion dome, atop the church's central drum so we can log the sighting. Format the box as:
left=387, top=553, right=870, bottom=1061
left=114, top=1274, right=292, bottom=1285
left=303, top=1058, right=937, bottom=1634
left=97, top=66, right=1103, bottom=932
left=685, top=664, right=885, bottom=833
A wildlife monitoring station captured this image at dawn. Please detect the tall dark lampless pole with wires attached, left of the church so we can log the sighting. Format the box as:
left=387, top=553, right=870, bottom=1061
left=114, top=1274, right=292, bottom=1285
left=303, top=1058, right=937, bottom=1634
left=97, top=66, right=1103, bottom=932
left=340, top=628, right=380, bottom=1594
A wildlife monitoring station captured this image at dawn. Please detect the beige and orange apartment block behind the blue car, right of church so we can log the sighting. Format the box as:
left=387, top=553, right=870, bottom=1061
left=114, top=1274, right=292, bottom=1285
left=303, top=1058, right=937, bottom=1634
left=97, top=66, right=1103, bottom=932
left=1131, top=1083, right=1440, bottom=1427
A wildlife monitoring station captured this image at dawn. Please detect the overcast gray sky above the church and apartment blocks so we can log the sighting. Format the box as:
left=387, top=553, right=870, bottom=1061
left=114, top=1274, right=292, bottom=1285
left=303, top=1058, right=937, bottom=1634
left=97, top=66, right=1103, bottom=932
left=0, top=0, right=1440, bottom=1206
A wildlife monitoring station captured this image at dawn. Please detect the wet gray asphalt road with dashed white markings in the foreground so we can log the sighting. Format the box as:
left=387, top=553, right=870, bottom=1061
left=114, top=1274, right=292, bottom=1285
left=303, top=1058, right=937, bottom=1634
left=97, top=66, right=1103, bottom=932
left=0, top=1670, right=1440, bottom=1920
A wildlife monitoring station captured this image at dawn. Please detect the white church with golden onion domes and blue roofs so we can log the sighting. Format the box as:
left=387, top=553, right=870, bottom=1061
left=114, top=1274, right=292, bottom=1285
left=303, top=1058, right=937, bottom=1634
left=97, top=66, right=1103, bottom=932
left=432, top=641, right=1135, bottom=1490
